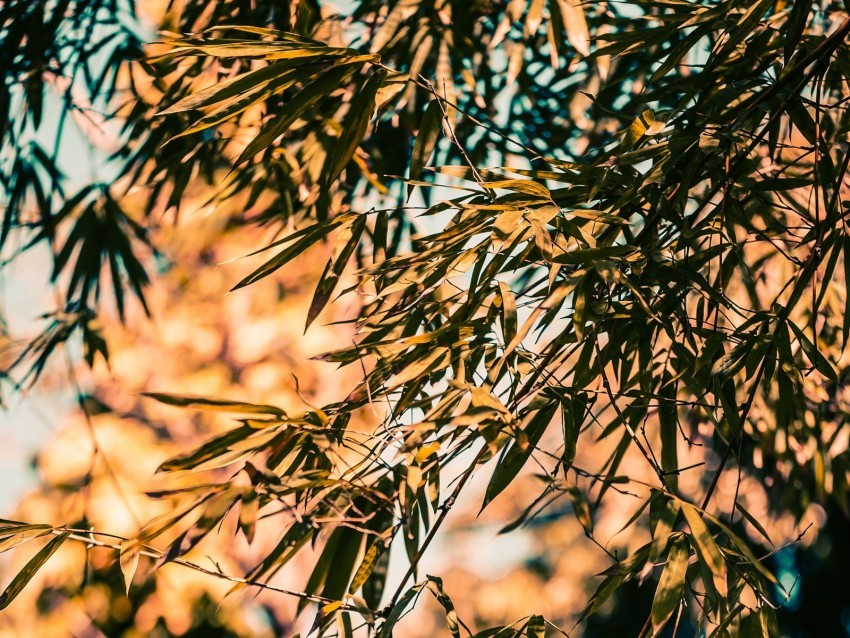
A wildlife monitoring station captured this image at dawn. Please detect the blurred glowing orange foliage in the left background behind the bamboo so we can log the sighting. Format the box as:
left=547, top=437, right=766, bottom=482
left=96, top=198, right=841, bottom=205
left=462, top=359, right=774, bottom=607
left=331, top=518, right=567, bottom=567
left=0, top=201, right=352, bottom=638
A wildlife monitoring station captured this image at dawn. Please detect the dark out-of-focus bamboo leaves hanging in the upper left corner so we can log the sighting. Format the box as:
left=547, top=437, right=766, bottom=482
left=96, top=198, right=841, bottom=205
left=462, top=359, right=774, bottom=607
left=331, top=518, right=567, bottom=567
left=0, top=0, right=326, bottom=386
